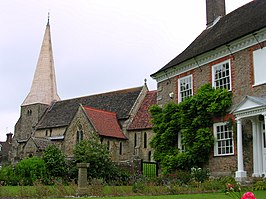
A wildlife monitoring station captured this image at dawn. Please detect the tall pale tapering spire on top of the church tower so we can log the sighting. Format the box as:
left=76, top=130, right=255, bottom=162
left=22, top=17, right=60, bottom=106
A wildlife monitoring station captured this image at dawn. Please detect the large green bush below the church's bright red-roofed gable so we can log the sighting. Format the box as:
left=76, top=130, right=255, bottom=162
left=74, top=136, right=128, bottom=182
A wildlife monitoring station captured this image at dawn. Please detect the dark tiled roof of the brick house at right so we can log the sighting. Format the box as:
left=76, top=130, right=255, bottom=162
left=151, top=0, right=266, bottom=76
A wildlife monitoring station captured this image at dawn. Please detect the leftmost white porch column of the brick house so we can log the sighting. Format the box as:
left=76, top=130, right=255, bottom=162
left=235, top=118, right=247, bottom=182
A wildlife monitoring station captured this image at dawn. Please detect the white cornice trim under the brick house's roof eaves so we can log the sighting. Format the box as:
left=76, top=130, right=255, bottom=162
left=152, top=28, right=266, bottom=83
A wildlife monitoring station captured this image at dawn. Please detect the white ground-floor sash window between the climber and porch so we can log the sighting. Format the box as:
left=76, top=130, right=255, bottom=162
left=213, top=122, right=235, bottom=156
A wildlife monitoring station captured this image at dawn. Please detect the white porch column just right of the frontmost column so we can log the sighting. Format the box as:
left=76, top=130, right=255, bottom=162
left=251, top=118, right=260, bottom=177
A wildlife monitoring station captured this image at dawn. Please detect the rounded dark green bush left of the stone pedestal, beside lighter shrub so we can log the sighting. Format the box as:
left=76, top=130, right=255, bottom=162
left=42, top=145, right=66, bottom=182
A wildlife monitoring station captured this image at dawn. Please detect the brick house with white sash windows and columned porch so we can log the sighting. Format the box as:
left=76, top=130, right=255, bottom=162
left=151, top=0, right=266, bottom=181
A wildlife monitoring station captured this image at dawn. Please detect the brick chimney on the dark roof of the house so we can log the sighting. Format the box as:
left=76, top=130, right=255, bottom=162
left=206, top=0, right=225, bottom=28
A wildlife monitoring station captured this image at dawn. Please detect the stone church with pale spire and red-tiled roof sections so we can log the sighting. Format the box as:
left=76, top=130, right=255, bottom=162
left=9, top=19, right=157, bottom=163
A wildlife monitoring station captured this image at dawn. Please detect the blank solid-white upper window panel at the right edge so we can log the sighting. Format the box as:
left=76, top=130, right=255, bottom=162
left=253, top=48, right=266, bottom=86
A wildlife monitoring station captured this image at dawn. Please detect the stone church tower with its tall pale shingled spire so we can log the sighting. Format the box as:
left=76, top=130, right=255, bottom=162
left=13, top=18, right=60, bottom=152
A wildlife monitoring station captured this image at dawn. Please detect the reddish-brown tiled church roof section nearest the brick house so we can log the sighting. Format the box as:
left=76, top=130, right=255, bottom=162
left=127, top=91, right=157, bottom=130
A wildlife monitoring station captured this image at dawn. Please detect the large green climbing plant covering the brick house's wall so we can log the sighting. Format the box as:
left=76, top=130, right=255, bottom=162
left=150, top=84, right=232, bottom=173
